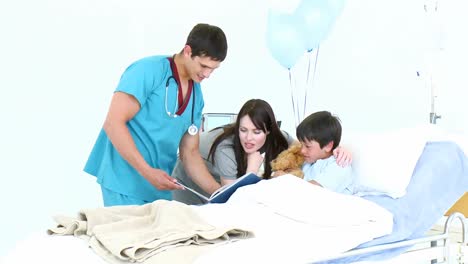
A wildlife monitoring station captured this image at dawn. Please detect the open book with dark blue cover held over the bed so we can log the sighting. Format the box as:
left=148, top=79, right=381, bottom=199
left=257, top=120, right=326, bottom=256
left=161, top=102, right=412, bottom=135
left=177, top=173, right=262, bottom=203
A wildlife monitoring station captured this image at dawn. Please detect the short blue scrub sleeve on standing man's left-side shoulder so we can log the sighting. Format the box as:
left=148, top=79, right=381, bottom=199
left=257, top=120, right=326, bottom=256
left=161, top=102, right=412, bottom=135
left=116, top=58, right=164, bottom=106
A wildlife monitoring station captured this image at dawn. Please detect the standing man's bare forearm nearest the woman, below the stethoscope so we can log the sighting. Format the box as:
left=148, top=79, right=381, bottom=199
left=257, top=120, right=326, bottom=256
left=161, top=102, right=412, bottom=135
left=179, top=133, right=221, bottom=194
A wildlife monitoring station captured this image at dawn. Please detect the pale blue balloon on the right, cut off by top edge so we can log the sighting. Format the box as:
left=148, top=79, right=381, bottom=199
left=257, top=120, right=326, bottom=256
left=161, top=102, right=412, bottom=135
left=294, top=0, right=338, bottom=51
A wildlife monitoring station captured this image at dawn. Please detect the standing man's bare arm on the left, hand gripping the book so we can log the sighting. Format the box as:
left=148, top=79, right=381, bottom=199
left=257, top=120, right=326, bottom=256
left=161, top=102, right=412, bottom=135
left=103, top=92, right=182, bottom=190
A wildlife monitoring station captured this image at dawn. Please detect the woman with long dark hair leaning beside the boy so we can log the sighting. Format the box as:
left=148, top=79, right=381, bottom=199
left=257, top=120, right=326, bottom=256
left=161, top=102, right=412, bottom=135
left=172, top=99, right=347, bottom=204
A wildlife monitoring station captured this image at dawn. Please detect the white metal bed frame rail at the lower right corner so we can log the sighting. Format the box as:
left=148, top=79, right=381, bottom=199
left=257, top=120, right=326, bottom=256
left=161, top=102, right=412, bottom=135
left=314, top=212, right=468, bottom=264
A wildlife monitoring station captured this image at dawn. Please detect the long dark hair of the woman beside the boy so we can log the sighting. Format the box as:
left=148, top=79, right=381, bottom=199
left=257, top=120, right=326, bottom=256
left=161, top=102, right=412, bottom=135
left=208, top=99, right=289, bottom=179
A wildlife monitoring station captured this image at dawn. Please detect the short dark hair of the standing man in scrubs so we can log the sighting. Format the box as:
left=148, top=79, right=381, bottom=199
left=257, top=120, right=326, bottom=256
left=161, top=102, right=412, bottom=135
left=185, top=24, right=227, bottom=61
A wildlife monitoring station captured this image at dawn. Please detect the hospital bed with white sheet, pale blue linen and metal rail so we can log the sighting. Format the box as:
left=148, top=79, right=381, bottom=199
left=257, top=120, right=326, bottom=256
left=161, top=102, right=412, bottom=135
left=4, top=138, right=468, bottom=264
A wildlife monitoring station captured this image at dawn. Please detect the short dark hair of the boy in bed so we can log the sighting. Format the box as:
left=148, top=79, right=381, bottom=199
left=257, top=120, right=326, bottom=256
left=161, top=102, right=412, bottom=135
left=296, top=111, right=341, bottom=150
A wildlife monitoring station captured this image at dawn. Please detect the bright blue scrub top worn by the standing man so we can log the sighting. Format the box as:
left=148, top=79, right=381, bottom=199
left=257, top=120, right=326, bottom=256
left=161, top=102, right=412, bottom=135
left=84, top=56, right=204, bottom=201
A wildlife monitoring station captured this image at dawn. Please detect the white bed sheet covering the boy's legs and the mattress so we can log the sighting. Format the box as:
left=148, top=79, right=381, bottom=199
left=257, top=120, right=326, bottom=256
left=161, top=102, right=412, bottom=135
left=4, top=175, right=393, bottom=264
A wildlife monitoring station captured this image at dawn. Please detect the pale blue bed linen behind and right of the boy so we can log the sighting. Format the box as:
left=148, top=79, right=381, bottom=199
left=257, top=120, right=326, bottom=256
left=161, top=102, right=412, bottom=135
left=321, top=142, right=468, bottom=263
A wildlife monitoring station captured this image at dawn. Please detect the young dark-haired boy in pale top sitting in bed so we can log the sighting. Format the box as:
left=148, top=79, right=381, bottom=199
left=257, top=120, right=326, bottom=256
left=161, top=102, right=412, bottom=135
left=296, top=111, right=354, bottom=194
